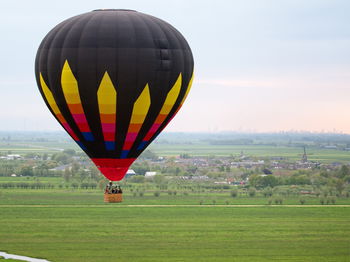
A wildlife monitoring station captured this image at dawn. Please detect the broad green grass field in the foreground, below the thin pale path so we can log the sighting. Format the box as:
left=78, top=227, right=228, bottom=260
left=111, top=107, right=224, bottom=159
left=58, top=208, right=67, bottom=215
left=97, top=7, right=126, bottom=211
left=0, top=205, right=350, bottom=262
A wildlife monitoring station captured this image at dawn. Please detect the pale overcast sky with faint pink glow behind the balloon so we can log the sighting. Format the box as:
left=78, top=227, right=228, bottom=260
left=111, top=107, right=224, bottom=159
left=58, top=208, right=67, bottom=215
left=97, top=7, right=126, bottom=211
left=0, top=0, right=350, bottom=133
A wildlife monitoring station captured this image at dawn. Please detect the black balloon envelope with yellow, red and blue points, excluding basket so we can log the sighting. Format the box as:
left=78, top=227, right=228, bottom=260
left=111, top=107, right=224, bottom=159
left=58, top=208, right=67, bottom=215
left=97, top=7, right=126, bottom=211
left=35, top=9, right=193, bottom=181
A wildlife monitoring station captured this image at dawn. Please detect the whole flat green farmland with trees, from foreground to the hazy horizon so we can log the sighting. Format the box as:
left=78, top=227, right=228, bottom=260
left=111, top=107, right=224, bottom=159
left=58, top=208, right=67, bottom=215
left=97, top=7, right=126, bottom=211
left=0, top=132, right=350, bottom=262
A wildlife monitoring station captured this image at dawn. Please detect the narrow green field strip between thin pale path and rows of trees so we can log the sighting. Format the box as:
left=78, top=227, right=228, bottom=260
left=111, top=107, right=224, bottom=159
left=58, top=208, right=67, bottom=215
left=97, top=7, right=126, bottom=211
left=0, top=189, right=350, bottom=206
